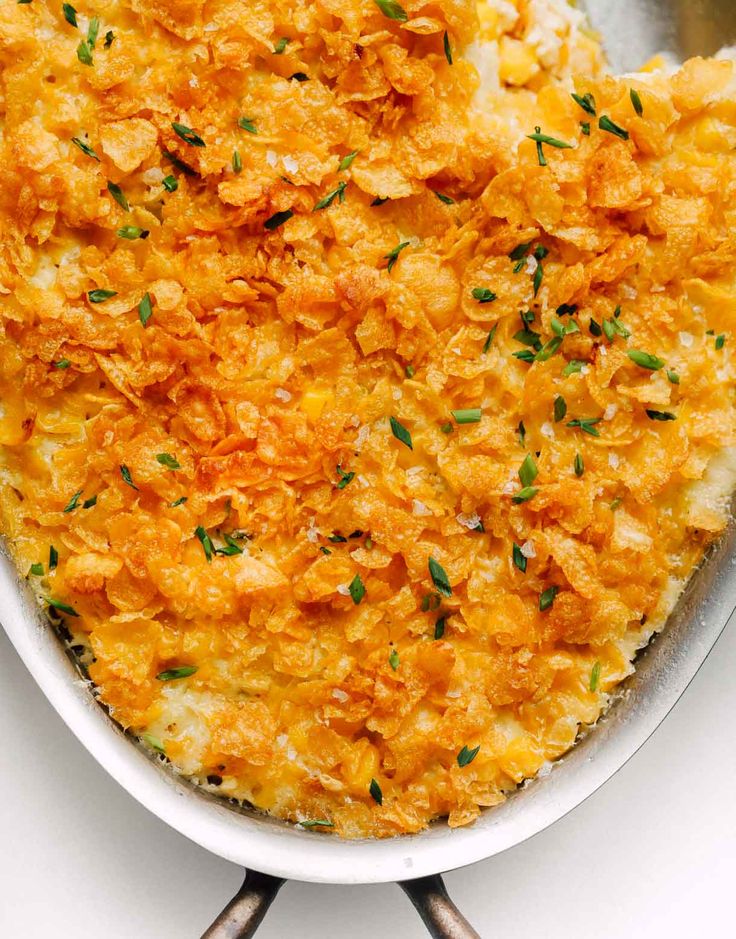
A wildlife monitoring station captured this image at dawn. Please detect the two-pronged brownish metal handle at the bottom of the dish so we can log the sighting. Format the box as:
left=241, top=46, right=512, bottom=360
left=202, top=870, right=480, bottom=939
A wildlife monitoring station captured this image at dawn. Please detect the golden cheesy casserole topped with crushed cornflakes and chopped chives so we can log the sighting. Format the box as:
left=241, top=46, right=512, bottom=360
left=0, top=0, right=736, bottom=838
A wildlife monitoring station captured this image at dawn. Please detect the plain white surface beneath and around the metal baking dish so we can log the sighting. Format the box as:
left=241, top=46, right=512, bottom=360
left=0, top=626, right=736, bottom=939
